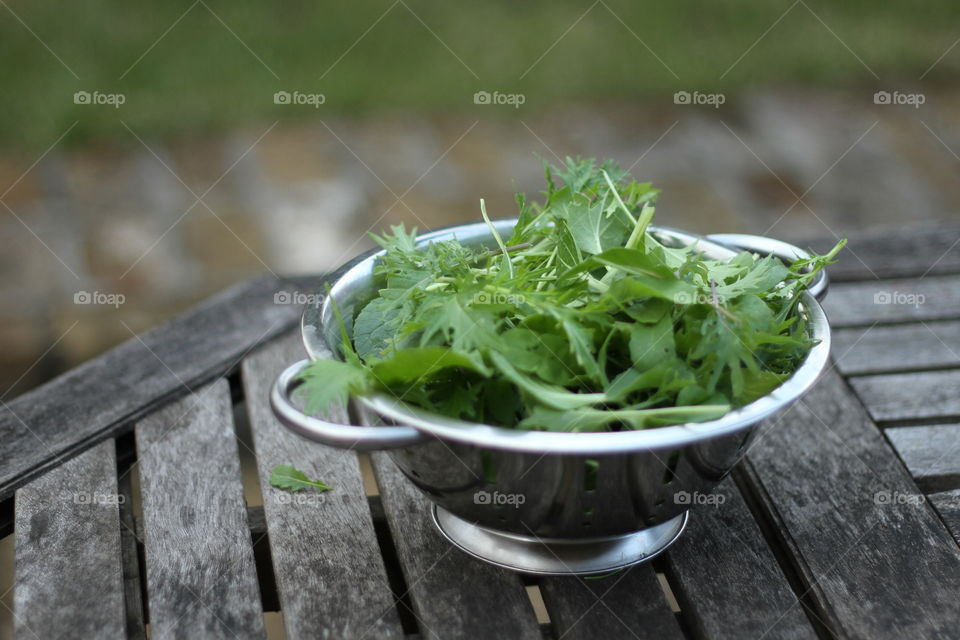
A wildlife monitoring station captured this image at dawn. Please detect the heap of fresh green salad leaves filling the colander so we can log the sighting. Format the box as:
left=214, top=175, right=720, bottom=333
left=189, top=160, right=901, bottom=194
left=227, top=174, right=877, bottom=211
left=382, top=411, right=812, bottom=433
left=300, top=158, right=844, bottom=431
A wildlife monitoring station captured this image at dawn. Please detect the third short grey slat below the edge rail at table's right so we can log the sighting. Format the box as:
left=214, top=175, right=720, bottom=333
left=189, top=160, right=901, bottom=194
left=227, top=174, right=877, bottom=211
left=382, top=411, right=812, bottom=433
left=850, top=370, right=960, bottom=422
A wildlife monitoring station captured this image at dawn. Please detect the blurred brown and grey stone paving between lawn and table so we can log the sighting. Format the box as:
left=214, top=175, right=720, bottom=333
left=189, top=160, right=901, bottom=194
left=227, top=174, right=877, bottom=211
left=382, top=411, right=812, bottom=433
left=0, top=91, right=960, bottom=398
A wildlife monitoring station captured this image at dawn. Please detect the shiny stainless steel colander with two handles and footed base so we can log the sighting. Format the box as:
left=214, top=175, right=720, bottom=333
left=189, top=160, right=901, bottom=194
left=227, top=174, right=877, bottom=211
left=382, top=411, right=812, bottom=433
left=271, top=220, right=830, bottom=574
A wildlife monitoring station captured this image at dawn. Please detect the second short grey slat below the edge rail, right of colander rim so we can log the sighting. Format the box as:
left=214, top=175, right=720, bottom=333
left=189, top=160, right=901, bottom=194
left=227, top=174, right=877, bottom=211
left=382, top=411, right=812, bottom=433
left=833, top=322, right=960, bottom=376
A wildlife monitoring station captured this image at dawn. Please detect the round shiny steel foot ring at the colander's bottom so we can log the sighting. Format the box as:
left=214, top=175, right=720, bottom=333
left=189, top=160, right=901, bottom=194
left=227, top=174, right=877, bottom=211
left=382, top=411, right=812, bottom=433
left=433, top=505, right=689, bottom=575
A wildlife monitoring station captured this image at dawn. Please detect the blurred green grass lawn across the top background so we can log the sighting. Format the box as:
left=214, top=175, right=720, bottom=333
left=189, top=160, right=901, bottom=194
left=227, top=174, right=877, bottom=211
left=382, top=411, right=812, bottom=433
left=0, top=0, right=960, bottom=147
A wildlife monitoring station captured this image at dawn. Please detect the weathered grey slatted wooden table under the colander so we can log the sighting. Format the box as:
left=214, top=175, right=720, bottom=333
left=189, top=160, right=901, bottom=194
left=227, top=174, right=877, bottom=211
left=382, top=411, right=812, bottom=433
left=0, top=228, right=960, bottom=640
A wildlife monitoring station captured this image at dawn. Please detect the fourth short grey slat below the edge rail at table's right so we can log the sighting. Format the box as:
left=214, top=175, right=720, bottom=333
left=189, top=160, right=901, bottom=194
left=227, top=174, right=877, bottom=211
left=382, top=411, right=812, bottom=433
left=886, top=424, right=960, bottom=493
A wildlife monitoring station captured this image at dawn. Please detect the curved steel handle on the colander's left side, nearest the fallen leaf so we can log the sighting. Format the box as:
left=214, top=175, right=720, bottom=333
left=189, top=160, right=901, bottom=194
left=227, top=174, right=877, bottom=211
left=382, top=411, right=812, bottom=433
left=270, top=360, right=428, bottom=451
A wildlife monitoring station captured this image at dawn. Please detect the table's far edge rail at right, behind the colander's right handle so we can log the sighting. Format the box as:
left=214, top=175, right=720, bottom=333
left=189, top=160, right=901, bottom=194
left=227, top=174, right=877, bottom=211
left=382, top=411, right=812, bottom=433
left=790, top=223, right=960, bottom=282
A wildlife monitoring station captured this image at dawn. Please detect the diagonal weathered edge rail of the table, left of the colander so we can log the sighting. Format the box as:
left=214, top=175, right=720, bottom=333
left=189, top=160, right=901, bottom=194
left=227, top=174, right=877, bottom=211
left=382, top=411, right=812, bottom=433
left=0, top=277, right=319, bottom=500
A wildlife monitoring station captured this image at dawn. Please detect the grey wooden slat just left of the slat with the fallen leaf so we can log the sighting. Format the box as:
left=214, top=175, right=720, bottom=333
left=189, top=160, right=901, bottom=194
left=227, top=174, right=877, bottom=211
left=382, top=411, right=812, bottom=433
left=136, top=380, right=265, bottom=640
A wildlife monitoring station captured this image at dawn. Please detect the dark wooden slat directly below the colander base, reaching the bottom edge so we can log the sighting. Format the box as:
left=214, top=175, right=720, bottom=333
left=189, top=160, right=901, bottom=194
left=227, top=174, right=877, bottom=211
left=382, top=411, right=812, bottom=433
left=540, top=564, right=684, bottom=640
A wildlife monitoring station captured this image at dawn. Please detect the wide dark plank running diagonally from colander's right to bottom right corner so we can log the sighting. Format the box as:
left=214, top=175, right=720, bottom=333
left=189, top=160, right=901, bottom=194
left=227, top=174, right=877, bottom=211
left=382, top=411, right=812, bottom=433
left=743, top=372, right=960, bottom=638
